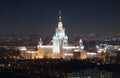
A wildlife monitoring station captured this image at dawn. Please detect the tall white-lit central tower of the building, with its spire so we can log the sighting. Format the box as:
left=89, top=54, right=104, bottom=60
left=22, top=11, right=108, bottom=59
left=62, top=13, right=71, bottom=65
left=53, top=11, right=68, bottom=54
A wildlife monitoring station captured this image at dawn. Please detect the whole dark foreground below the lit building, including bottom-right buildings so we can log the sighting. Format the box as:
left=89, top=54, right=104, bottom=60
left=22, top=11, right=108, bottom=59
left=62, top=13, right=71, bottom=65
left=0, top=59, right=120, bottom=78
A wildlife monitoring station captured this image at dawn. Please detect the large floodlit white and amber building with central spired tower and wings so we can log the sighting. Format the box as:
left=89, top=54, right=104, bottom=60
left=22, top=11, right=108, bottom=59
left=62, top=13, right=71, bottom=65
left=19, top=12, right=84, bottom=58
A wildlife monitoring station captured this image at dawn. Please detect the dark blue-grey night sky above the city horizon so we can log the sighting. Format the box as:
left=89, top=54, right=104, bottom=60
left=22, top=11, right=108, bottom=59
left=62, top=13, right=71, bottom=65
left=0, top=0, right=120, bottom=34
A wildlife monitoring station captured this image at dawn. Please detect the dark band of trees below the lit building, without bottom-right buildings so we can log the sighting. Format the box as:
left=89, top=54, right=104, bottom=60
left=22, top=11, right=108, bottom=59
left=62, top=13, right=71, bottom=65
left=0, top=59, right=120, bottom=78
